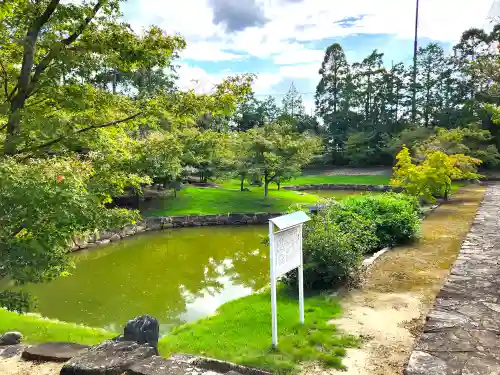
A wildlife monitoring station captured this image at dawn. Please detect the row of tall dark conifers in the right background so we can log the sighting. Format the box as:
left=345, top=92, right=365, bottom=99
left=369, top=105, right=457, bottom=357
left=315, top=25, right=500, bottom=167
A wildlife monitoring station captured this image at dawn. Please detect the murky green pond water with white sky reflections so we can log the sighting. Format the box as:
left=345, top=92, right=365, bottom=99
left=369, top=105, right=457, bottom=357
left=22, top=227, right=268, bottom=333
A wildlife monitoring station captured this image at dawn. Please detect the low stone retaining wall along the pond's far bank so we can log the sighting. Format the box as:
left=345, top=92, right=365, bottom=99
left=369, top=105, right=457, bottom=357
left=70, top=212, right=283, bottom=251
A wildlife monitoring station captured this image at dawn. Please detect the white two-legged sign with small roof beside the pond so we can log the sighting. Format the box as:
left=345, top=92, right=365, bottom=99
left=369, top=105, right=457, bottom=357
left=269, top=211, right=310, bottom=348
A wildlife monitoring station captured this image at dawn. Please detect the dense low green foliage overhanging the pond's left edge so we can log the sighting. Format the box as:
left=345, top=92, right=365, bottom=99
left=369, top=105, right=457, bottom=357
left=0, top=158, right=137, bottom=310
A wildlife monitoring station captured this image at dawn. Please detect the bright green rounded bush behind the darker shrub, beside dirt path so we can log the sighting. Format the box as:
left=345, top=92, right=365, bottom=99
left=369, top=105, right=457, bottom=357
left=343, top=193, right=420, bottom=248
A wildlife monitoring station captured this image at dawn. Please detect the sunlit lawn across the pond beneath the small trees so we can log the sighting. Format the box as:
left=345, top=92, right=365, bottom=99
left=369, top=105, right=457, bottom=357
left=143, top=176, right=389, bottom=216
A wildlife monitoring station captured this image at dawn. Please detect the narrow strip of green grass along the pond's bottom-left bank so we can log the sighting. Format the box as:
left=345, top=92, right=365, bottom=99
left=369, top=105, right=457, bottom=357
left=0, top=308, right=117, bottom=345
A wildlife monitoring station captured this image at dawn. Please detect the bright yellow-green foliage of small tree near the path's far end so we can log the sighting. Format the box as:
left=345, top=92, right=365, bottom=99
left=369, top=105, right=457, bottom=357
left=391, top=147, right=481, bottom=202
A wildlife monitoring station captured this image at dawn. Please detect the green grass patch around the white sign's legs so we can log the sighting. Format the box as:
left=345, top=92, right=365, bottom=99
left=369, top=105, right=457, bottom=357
left=159, top=291, right=358, bottom=373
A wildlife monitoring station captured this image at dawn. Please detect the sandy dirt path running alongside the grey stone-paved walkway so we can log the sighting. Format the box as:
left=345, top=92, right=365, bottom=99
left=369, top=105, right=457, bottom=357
left=320, top=187, right=484, bottom=375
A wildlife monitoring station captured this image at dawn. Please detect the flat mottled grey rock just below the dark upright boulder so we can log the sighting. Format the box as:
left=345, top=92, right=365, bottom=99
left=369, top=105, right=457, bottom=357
left=60, top=341, right=156, bottom=375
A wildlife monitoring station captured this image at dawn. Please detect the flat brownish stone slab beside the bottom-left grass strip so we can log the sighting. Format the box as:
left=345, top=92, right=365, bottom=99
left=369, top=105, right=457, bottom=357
left=21, top=342, right=89, bottom=362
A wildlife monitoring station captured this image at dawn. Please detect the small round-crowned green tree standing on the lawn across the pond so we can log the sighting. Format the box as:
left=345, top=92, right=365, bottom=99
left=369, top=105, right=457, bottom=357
left=234, top=123, right=321, bottom=197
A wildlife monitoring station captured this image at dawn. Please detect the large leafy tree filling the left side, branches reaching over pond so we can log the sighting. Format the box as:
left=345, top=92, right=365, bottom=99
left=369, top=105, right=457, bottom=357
left=0, top=0, right=253, bottom=308
